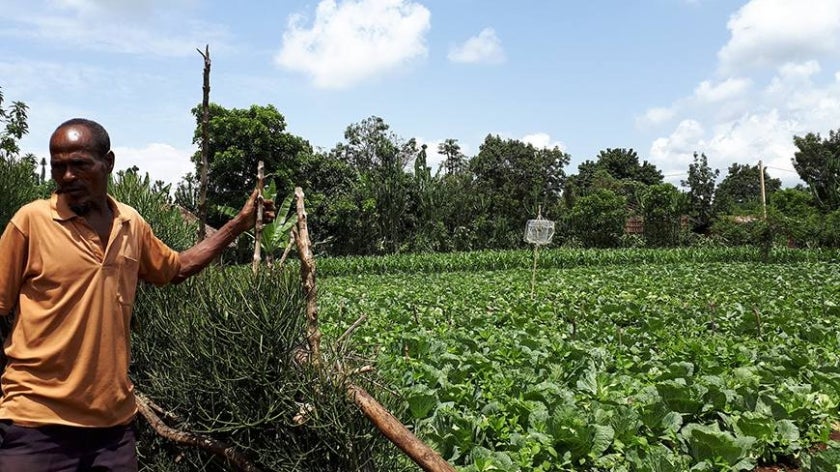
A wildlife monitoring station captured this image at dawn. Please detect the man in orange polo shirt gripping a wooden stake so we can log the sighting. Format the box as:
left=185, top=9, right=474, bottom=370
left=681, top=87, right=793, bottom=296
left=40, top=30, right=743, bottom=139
left=0, top=118, right=274, bottom=472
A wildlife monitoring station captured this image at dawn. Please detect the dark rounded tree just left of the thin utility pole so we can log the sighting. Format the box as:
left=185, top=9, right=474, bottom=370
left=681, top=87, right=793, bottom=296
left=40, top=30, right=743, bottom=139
left=714, top=163, right=782, bottom=215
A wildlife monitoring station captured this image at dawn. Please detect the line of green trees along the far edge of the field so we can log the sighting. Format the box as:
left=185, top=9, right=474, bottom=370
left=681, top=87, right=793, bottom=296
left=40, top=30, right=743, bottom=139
left=0, top=90, right=840, bottom=260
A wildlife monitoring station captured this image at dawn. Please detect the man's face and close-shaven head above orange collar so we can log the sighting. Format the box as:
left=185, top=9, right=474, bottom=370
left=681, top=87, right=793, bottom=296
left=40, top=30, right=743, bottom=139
left=50, top=125, right=114, bottom=208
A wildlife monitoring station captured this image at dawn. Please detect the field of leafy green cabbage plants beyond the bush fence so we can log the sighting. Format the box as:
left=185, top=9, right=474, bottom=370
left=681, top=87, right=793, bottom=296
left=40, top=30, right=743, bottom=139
left=319, top=251, right=840, bottom=472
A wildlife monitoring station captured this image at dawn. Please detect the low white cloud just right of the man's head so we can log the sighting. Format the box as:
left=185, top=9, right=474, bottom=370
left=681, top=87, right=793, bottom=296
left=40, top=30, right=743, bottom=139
left=114, top=143, right=195, bottom=190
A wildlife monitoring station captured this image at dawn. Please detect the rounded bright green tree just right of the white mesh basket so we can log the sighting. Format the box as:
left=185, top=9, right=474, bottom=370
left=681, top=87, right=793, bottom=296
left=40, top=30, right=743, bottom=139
left=568, top=189, right=628, bottom=248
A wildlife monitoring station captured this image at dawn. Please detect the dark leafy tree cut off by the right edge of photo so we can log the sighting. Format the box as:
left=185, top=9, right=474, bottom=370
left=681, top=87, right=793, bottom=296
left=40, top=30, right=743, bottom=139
left=793, top=130, right=840, bottom=211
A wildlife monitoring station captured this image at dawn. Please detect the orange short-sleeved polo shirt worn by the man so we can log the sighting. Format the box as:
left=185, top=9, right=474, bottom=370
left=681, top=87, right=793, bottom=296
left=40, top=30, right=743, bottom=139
left=0, top=194, right=180, bottom=427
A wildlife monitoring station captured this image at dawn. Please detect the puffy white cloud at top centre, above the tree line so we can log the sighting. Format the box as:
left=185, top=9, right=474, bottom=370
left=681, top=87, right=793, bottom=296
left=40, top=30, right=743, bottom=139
left=275, top=0, right=431, bottom=89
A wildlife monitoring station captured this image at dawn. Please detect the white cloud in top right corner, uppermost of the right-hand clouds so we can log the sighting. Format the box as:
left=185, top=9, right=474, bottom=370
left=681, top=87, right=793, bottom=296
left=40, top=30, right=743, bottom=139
left=718, top=0, right=840, bottom=73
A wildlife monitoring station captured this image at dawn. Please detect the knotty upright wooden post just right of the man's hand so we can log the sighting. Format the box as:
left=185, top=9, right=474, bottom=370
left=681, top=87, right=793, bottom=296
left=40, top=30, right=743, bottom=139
left=295, top=187, right=321, bottom=368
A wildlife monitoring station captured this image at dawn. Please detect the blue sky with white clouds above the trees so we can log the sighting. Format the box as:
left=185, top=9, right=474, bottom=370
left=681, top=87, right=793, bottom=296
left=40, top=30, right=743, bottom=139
left=0, top=0, right=840, bottom=185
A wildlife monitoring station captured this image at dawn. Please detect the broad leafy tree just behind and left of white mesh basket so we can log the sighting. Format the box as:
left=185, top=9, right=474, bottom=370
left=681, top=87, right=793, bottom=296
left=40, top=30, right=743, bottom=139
left=470, top=135, right=569, bottom=248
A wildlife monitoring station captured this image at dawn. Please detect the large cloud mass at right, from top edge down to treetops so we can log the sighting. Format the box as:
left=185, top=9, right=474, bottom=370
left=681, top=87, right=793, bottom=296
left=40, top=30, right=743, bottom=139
left=637, top=0, right=840, bottom=186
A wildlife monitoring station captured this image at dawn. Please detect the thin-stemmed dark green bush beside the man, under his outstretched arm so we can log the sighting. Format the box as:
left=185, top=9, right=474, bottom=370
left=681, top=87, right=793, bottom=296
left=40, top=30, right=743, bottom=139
left=131, top=267, right=401, bottom=472
